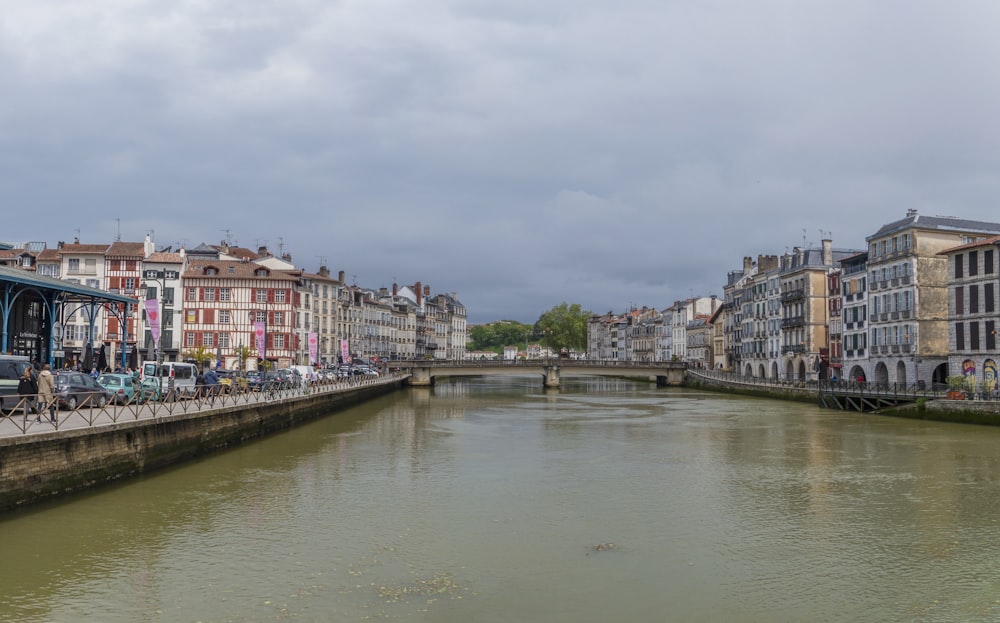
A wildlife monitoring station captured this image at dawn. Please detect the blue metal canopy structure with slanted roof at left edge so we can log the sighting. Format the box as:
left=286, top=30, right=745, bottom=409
left=0, top=266, right=136, bottom=364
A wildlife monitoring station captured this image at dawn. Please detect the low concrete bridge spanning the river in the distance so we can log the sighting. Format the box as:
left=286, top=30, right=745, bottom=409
left=391, top=358, right=686, bottom=387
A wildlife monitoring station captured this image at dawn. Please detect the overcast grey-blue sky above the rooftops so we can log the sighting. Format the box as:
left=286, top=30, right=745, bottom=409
left=0, top=0, right=1000, bottom=322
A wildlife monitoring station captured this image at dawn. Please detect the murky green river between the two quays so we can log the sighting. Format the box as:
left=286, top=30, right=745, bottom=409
left=0, top=377, right=1000, bottom=623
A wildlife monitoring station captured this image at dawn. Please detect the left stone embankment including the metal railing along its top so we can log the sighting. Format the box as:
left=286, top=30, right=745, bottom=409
left=0, top=374, right=407, bottom=511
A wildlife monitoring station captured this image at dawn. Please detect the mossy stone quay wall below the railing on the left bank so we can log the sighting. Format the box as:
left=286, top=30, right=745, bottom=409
left=0, top=378, right=406, bottom=511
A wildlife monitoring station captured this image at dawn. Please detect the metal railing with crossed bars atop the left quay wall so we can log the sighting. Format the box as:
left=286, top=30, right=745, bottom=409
left=0, top=372, right=409, bottom=437
